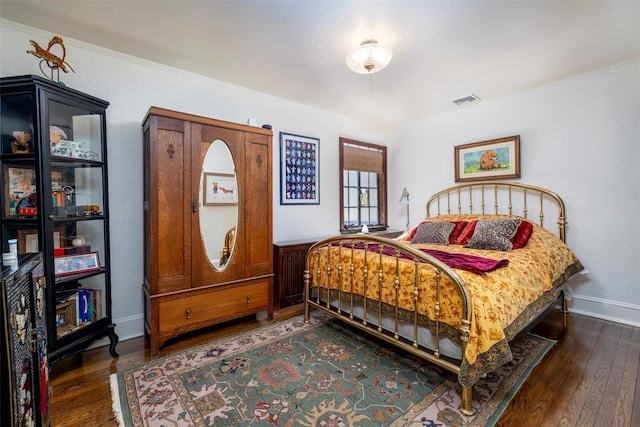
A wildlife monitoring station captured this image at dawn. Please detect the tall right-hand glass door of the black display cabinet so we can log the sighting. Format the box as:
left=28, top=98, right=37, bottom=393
left=42, top=96, right=108, bottom=338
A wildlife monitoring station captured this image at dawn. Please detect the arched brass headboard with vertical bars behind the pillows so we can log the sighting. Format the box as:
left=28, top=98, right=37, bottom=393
left=427, top=181, right=567, bottom=242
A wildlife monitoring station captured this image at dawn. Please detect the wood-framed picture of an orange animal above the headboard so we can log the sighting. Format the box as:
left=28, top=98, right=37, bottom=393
left=454, top=135, right=520, bottom=182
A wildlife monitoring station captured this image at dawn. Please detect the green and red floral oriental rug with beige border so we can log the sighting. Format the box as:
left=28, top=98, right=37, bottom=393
left=111, top=312, right=554, bottom=427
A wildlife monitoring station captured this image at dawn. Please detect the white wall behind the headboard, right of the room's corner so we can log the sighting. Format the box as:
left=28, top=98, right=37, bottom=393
left=389, top=60, right=640, bottom=326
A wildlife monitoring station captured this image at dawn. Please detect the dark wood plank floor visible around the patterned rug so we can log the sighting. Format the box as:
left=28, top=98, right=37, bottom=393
left=50, top=307, right=640, bottom=427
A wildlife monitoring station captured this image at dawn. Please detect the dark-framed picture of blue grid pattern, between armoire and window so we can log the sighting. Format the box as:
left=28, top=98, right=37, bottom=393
left=280, top=132, right=320, bottom=205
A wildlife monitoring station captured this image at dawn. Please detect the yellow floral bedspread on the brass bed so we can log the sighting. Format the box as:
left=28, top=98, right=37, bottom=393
left=310, top=215, right=582, bottom=386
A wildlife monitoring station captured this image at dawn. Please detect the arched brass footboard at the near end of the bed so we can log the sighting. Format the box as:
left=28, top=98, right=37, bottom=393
left=304, top=235, right=473, bottom=415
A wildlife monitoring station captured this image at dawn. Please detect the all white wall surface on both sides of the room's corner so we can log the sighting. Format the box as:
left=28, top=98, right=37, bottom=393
left=0, top=20, right=640, bottom=339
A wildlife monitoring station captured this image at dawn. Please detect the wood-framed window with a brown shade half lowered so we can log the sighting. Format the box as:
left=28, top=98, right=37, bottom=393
left=340, top=138, right=387, bottom=233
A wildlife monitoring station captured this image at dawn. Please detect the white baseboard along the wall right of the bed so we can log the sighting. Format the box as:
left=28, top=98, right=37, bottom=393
left=569, top=294, right=640, bottom=327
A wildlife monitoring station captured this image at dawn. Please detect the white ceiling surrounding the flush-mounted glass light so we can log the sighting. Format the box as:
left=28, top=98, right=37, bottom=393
left=0, top=0, right=640, bottom=127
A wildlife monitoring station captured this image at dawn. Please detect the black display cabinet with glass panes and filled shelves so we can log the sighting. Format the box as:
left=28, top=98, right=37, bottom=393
left=0, top=76, right=118, bottom=364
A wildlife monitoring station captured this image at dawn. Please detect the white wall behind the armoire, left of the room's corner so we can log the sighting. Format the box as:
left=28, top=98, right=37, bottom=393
left=0, top=20, right=389, bottom=340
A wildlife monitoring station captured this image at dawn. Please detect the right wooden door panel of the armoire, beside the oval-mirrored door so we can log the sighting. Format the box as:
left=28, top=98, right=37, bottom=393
left=245, top=134, right=273, bottom=276
